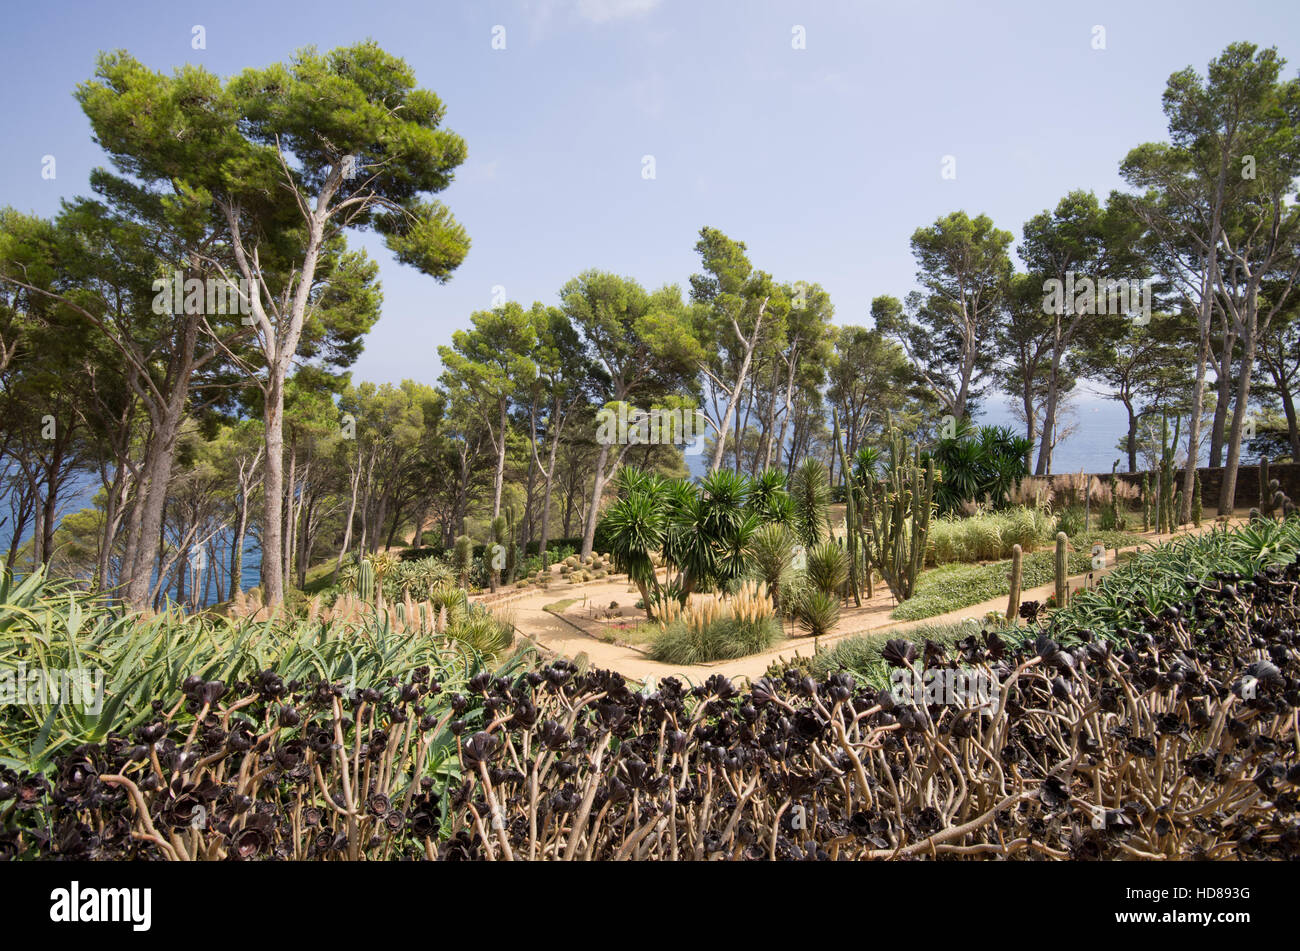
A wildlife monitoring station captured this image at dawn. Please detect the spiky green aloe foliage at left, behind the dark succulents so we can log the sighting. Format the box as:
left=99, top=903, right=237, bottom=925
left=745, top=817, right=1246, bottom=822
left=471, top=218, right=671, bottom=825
left=0, top=563, right=499, bottom=769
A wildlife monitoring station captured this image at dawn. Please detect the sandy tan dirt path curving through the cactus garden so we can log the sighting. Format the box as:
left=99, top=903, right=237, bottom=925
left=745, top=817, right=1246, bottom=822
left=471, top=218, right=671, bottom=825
left=475, top=518, right=1238, bottom=683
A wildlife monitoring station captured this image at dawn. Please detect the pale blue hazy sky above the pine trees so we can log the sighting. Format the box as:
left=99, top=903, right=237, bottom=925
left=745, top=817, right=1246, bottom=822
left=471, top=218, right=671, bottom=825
left=0, top=0, right=1300, bottom=470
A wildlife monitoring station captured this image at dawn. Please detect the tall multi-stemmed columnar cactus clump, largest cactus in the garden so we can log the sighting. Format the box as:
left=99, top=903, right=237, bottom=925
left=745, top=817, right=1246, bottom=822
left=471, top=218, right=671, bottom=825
left=863, top=420, right=935, bottom=602
